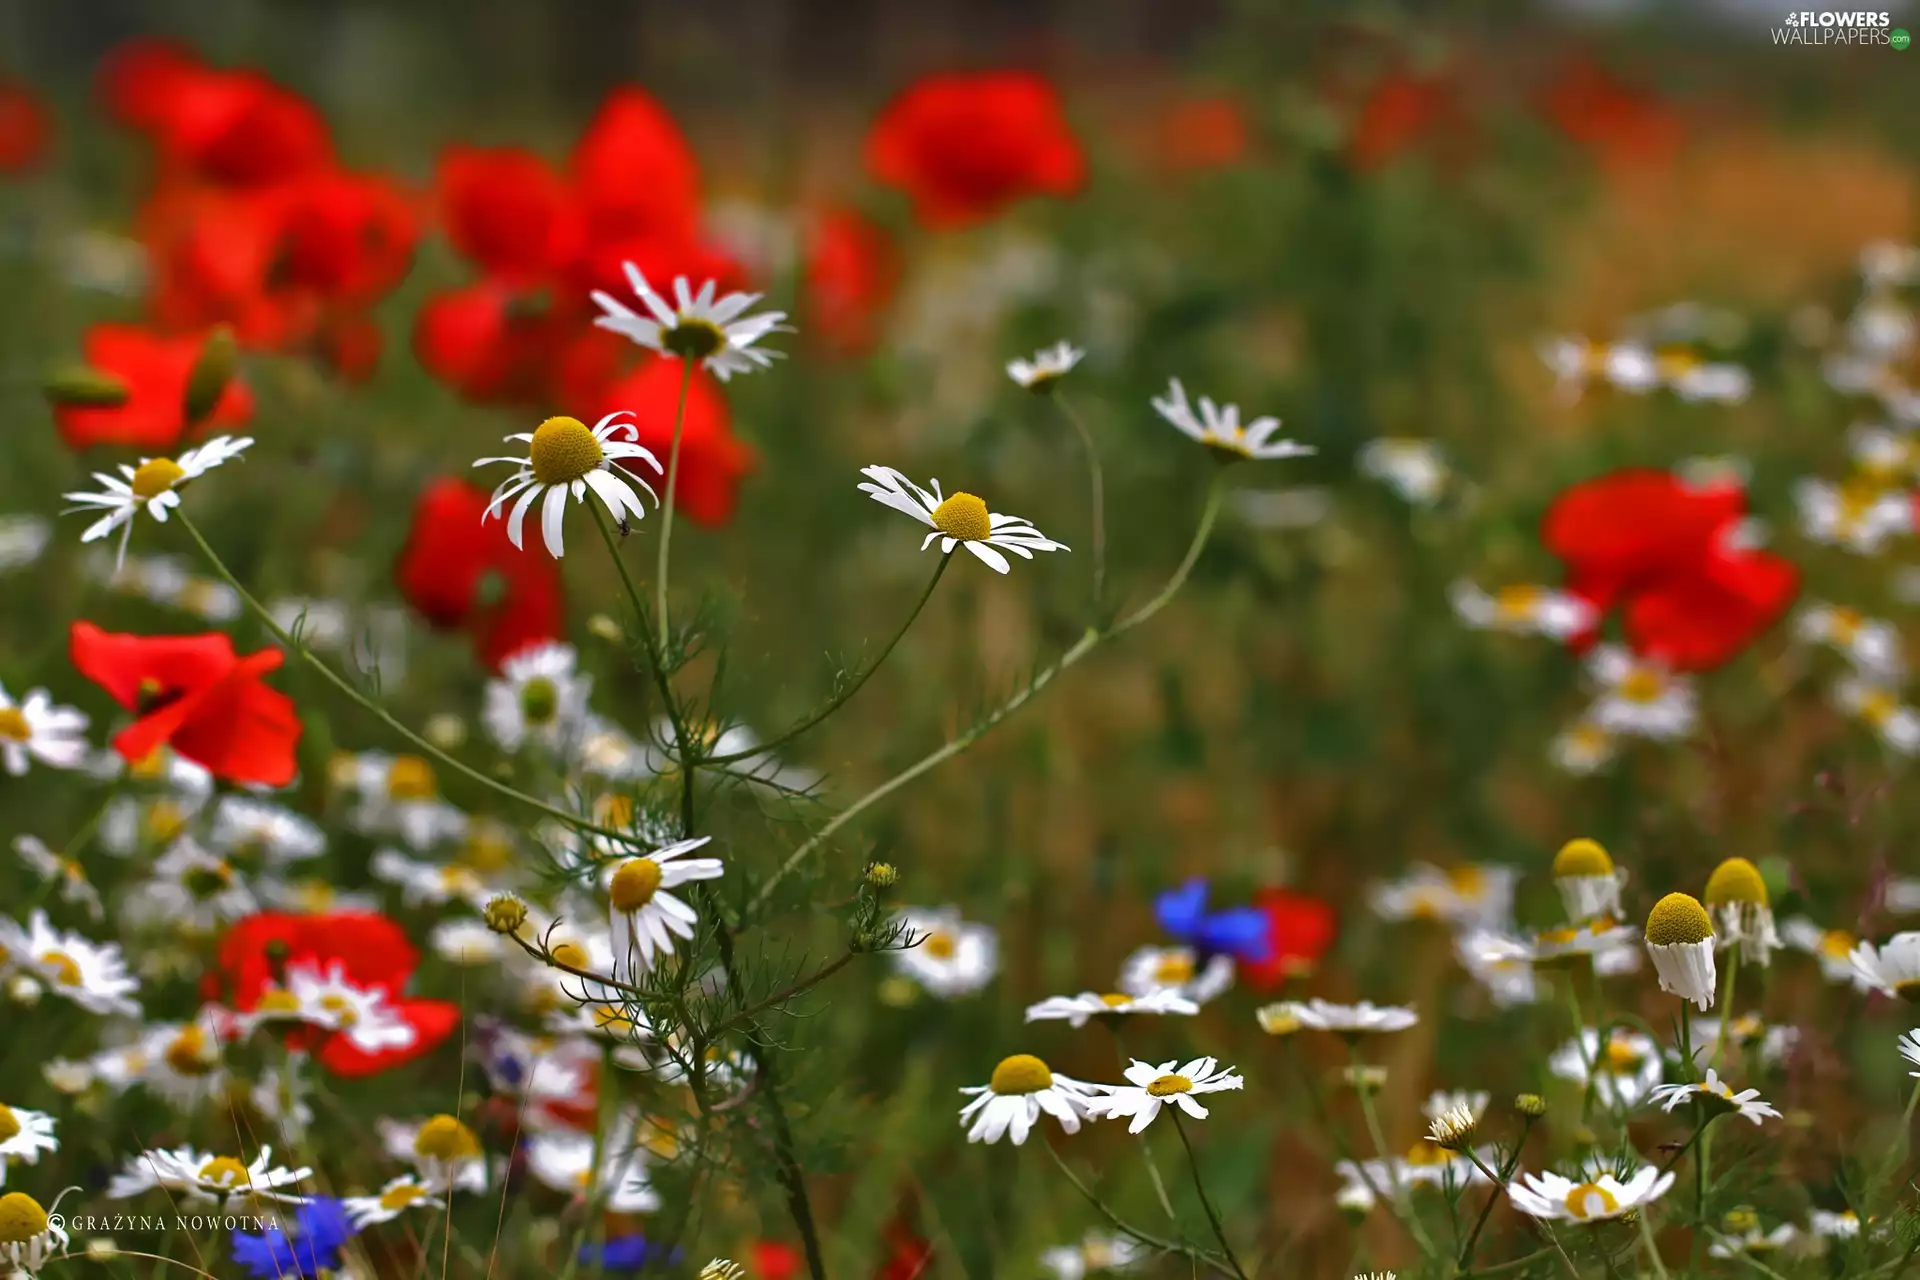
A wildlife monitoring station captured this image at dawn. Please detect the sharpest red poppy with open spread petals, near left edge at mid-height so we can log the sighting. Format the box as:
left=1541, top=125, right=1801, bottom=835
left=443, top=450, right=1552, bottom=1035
left=71, top=622, right=300, bottom=787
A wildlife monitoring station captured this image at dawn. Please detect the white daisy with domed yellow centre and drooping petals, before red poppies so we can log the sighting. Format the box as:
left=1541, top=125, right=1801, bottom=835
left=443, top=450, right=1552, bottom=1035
left=474, top=411, right=660, bottom=560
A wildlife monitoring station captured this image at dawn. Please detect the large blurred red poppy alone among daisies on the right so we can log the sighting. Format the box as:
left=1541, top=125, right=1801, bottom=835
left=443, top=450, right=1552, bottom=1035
left=1540, top=468, right=1799, bottom=672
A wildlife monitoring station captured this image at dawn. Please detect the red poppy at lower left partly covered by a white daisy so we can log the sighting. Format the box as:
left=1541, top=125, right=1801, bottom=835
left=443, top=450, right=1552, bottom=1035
left=209, top=912, right=461, bottom=1077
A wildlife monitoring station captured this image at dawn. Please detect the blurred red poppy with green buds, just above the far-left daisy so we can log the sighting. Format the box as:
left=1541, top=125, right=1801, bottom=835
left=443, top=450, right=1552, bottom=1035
left=54, top=324, right=253, bottom=451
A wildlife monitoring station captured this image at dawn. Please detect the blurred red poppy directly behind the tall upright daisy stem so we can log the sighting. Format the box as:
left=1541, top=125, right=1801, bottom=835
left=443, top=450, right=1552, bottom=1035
left=591, top=357, right=758, bottom=526
